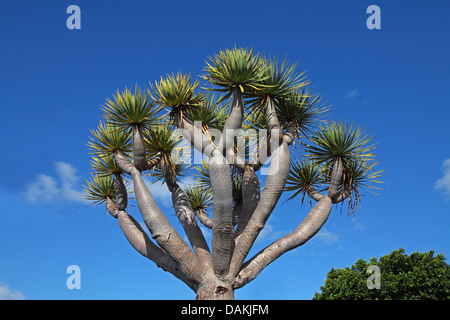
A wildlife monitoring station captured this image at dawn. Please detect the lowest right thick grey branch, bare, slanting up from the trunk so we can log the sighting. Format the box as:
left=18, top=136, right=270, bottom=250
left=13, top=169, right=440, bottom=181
left=233, top=196, right=332, bottom=289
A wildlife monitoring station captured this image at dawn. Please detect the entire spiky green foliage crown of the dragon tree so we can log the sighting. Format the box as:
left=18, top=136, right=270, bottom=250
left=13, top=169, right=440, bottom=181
left=86, top=47, right=382, bottom=218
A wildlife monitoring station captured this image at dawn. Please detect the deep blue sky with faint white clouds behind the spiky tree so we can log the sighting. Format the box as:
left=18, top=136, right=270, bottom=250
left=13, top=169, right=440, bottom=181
left=0, top=0, right=450, bottom=299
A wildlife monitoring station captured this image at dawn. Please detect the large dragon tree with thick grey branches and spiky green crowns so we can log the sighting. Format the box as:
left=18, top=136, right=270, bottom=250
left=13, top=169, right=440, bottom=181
left=85, top=48, right=381, bottom=300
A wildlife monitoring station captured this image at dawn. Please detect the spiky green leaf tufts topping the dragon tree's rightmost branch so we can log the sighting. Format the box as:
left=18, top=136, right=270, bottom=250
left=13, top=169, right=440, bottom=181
left=286, top=122, right=382, bottom=213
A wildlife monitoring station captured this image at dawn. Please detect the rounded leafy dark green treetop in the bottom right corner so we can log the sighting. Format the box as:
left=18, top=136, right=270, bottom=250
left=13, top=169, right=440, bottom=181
left=313, top=248, right=450, bottom=300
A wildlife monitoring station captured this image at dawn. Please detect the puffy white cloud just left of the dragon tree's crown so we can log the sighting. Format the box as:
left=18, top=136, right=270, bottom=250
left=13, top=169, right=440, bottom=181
left=25, top=162, right=86, bottom=203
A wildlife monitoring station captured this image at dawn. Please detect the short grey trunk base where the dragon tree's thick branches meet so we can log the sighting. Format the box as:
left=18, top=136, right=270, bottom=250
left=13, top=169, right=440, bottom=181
left=195, top=274, right=234, bottom=300
